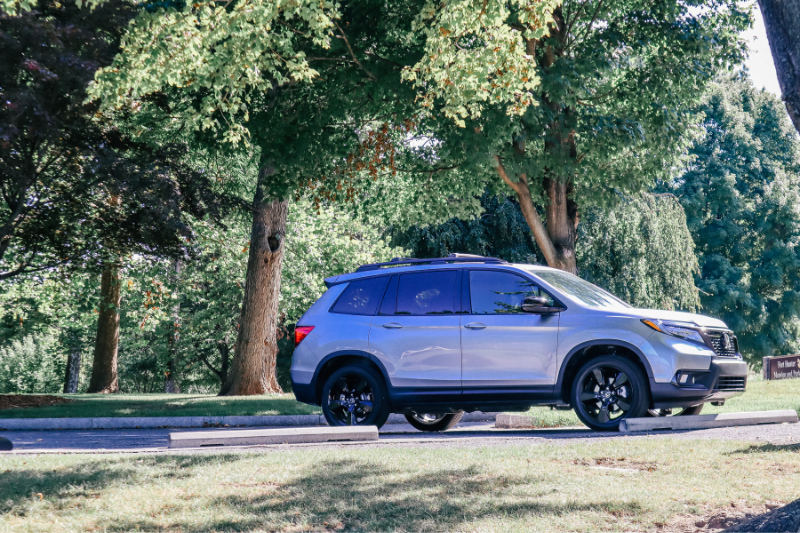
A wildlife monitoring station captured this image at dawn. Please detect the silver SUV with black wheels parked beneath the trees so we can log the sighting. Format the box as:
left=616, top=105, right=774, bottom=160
left=291, top=254, right=747, bottom=431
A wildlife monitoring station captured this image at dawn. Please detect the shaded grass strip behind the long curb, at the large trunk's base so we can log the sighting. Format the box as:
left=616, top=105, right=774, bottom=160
left=0, top=394, right=320, bottom=418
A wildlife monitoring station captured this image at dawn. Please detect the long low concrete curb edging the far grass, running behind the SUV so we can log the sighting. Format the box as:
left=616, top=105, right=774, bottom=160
left=0, top=412, right=497, bottom=431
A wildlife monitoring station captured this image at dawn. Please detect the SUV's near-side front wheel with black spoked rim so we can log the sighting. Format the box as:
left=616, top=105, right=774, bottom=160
left=570, top=355, right=650, bottom=431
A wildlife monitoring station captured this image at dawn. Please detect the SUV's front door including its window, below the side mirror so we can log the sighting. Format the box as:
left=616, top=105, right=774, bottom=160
left=461, top=270, right=559, bottom=401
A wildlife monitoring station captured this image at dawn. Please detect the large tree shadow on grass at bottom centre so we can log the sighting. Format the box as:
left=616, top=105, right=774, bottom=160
left=98, top=454, right=642, bottom=532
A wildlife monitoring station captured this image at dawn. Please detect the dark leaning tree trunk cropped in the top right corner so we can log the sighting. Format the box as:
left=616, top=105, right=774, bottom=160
left=758, top=0, right=800, bottom=132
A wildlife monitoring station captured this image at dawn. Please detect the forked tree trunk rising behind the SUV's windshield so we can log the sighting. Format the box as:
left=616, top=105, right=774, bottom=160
left=495, top=7, right=579, bottom=274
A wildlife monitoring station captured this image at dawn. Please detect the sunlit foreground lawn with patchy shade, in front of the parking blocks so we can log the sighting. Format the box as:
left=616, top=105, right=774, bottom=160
left=0, top=439, right=800, bottom=533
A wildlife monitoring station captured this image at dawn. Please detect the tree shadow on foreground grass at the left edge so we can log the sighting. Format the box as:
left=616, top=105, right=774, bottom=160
left=0, top=454, right=247, bottom=513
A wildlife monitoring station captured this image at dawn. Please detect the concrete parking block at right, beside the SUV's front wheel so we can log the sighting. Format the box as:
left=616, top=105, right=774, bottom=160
left=619, top=409, right=797, bottom=432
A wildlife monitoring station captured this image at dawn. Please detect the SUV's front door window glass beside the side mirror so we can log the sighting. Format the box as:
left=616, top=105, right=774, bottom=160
left=469, top=270, right=555, bottom=315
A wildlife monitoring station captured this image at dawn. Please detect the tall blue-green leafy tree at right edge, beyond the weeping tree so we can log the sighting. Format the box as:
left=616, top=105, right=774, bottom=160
left=665, top=76, right=800, bottom=362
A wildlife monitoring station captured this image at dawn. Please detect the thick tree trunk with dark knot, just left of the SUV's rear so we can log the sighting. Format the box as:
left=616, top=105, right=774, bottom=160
left=220, top=164, right=289, bottom=396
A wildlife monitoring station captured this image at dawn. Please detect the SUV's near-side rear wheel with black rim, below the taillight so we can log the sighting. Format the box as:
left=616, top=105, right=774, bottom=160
left=321, top=365, right=391, bottom=429
